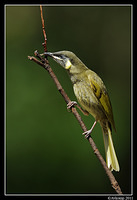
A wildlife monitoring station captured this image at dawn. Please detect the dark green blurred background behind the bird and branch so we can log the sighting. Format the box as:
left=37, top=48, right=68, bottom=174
left=5, top=5, right=131, bottom=194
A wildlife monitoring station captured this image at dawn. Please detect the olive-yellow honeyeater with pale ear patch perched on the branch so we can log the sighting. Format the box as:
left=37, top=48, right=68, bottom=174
left=44, top=51, right=120, bottom=171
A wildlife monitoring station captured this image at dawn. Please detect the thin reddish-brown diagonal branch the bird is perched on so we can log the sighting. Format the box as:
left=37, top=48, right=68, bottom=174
left=28, top=6, right=122, bottom=194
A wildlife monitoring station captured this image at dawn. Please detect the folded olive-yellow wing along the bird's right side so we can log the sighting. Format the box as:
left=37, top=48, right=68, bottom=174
left=87, top=70, right=116, bottom=130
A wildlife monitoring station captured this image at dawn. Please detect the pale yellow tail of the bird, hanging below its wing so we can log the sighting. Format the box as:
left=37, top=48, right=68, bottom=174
left=102, top=125, right=120, bottom=171
